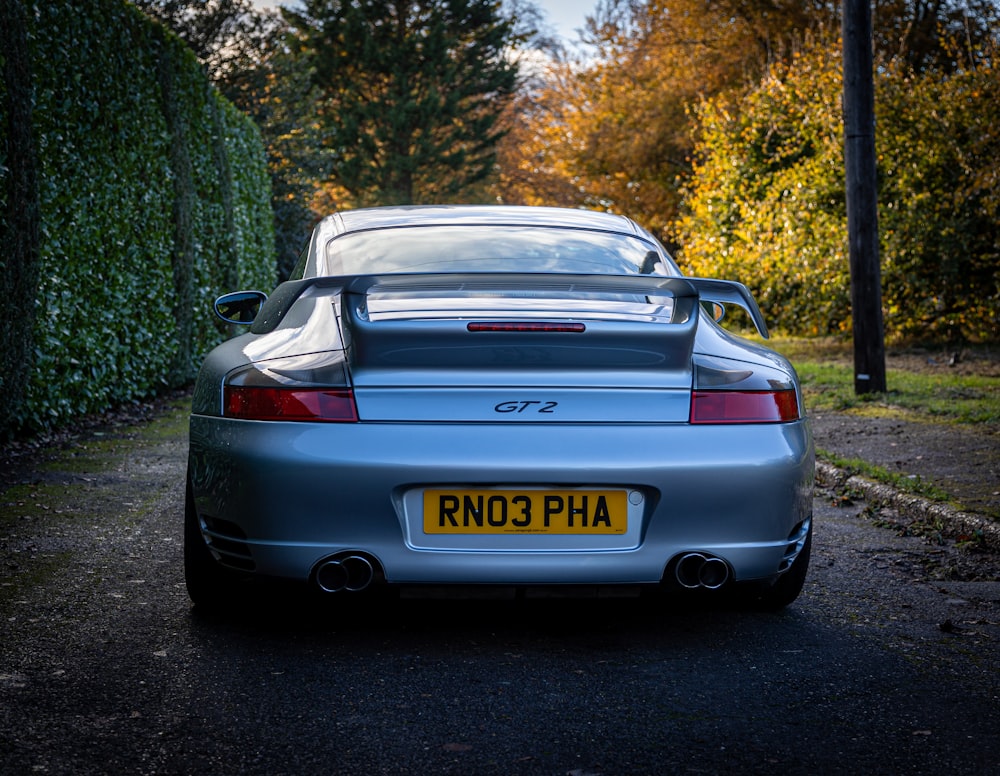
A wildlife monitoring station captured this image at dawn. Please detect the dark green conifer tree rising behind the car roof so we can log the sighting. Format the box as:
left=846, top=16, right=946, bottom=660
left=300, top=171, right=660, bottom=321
left=286, top=0, right=520, bottom=206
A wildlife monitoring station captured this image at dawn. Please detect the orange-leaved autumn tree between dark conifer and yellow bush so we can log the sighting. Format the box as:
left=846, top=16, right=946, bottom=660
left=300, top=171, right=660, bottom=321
left=501, top=0, right=836, bottom=238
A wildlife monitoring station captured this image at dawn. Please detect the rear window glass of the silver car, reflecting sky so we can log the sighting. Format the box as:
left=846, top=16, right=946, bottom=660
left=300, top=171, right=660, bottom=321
left=326, top=226, right=680, bottom=275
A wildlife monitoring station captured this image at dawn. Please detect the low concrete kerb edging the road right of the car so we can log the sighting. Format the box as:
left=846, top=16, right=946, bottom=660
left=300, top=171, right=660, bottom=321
left=816, top=461, right=1000, bottom=551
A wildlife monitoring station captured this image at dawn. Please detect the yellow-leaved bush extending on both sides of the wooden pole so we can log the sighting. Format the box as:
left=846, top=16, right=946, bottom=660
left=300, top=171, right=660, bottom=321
left=677, top=36, right=1000, bottom=342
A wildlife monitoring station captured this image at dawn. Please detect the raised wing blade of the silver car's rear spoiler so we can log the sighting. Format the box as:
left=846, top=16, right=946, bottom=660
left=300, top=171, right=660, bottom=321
left=250, top=272, right=768, bottom=339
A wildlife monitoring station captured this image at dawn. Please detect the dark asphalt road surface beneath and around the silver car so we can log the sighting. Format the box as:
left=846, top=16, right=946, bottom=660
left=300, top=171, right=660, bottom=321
left=0, top=410, right=1000, bottom=776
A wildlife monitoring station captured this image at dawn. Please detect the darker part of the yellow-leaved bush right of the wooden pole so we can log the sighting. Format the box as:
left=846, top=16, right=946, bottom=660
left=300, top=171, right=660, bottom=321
left=876, top=48, right=1000, bottom=342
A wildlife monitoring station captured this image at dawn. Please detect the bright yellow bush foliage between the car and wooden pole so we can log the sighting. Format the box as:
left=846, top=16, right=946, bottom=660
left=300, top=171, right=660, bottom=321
left=676, top=43, right=850, bottom=335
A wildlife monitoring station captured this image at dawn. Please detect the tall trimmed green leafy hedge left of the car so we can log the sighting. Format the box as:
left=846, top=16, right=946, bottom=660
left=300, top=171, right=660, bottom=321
left=0, top=0, right=275, bottom=435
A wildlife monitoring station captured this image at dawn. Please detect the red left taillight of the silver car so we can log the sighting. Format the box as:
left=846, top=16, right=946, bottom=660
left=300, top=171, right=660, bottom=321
left=224, top=385, right=358, bottom=423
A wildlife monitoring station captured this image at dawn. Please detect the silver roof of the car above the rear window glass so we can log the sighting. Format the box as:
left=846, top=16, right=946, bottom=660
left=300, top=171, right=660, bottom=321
left=320, top=205, right=648, bottom=238
